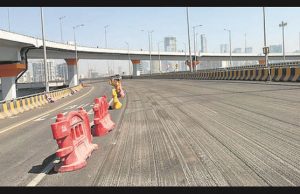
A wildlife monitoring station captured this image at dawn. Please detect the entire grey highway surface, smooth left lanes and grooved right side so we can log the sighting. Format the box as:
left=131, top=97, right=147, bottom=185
left=0, top=79, right=300, bottom=186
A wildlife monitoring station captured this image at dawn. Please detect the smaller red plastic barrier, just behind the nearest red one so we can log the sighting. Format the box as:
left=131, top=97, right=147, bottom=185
left=92, top=96, right=115, bottom=136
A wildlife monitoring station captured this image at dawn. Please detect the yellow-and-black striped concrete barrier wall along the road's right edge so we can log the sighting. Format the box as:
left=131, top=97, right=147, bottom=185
left=123, top=66, right=300, bottom=82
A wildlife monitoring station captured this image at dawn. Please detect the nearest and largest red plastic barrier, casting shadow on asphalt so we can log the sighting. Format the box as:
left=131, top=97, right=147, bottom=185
left=51, top=108, right=98, bottom=172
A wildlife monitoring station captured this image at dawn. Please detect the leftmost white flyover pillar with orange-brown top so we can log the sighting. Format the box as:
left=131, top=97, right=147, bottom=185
left=0, top=63, right=26, bottom=100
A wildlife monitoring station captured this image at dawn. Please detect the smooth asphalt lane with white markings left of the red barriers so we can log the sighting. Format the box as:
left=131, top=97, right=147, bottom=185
left=0, top=81, right=121, bottom=186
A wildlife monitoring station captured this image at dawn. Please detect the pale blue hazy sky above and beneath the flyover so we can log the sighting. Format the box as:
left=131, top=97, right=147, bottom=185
left=0, top=7, right=300, bottom=74
